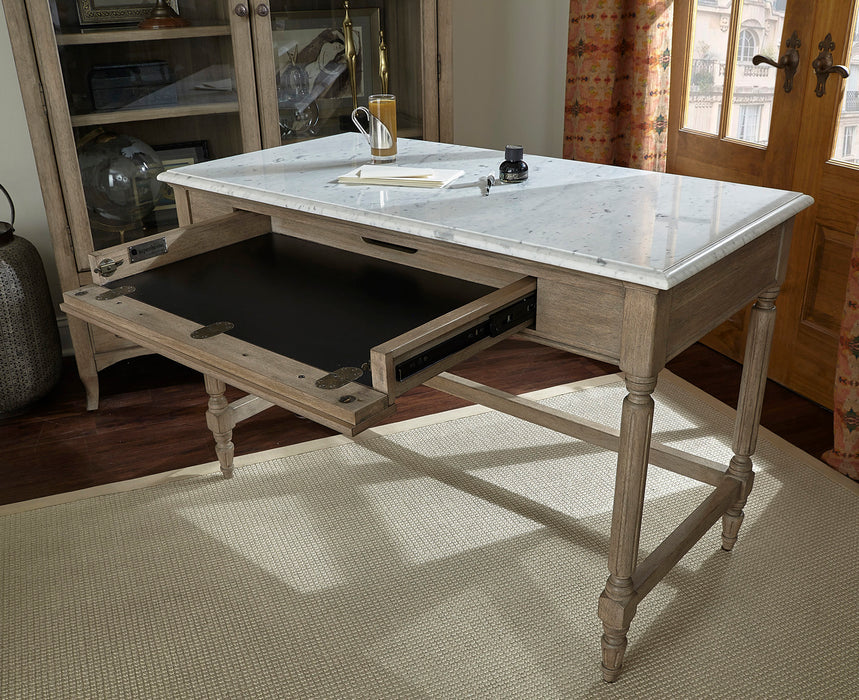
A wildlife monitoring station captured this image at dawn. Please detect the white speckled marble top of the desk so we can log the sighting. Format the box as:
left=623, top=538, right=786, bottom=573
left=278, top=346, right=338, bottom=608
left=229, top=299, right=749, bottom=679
left=159, top=134, right=813, bottom=289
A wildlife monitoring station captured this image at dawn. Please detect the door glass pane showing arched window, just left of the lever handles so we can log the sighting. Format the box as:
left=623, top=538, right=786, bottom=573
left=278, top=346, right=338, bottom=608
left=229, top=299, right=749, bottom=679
left=725, top=0, right=786, bottom=145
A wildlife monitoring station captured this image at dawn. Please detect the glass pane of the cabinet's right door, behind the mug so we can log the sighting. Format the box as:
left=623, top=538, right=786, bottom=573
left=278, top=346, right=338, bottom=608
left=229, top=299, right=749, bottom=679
left=263, top=0, right=424, bottom=143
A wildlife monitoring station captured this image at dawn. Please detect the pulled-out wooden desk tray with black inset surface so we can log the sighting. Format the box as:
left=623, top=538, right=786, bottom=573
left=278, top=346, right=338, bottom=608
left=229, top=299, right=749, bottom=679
left=64, top=228, right=536, bottom=434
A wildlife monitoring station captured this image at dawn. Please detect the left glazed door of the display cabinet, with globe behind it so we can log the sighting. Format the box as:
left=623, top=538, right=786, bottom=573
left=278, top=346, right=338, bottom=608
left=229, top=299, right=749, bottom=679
left=30, top=0, right=260, bottom=258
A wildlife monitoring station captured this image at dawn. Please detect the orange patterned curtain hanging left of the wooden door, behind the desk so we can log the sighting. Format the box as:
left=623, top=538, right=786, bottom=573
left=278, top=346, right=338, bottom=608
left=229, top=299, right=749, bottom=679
left=564, top=0, right=673, bottom=170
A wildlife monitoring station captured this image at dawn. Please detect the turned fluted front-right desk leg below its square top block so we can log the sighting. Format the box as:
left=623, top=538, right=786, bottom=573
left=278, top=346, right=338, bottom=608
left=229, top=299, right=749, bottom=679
left=599, top=377, right=656, bottom=683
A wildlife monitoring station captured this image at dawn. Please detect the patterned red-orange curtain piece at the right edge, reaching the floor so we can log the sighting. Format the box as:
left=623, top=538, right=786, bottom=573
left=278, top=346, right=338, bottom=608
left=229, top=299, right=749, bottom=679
left=823, top=231, right=859, bottom=480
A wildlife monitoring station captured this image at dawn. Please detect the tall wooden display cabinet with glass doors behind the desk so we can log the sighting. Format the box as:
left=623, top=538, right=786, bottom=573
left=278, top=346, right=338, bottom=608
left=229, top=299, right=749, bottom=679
left=3, top=0, right=452, bottom=409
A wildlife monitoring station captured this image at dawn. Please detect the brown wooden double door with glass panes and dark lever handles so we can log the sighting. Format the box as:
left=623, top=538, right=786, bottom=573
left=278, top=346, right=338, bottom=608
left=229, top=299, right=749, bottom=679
left=668, top=0, right=859, bottom=407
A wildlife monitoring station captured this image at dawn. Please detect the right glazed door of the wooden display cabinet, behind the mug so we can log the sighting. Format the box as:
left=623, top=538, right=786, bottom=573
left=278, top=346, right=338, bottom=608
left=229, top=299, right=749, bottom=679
left=251, top=0, right=438, bottom=147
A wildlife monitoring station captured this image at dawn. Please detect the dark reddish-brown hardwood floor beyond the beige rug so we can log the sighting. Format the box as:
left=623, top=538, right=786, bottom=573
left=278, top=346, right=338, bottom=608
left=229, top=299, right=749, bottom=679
left=0, top=340, right=832, bottom=504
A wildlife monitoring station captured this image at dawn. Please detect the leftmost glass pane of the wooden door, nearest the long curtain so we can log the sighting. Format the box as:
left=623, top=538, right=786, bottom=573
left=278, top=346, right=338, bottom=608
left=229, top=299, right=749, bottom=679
left=683, top=0, right=731, bottom=134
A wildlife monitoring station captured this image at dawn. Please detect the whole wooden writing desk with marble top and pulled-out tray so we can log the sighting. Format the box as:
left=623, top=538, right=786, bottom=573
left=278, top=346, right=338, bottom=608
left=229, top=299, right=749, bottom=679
left=63, top=134, right=812, bottom=681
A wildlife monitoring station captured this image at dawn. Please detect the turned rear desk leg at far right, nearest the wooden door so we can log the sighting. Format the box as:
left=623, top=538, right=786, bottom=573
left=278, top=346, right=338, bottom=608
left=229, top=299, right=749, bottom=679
left=722, top=289, right=779, bottom=551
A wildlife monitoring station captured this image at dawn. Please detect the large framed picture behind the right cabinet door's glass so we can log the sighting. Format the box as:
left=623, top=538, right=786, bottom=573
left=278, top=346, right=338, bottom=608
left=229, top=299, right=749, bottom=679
left=272, top=8, right=381, bottom=114
